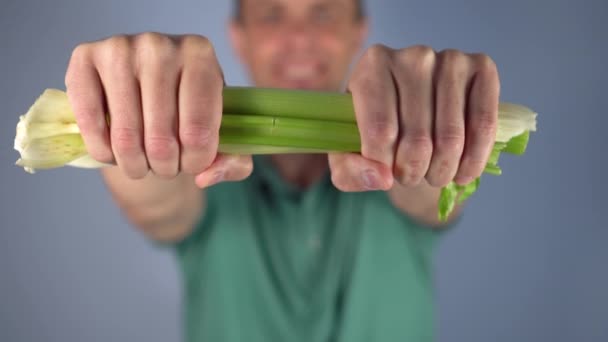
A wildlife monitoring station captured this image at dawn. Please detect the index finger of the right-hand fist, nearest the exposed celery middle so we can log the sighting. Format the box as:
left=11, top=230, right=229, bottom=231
left=348, top=45, right=399, bottom=167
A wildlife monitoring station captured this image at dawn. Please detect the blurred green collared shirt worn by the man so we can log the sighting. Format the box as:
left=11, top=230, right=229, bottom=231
left=175, top=156, right=439, bottom=342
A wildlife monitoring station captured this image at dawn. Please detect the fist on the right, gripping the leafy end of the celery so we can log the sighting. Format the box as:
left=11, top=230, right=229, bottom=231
left=329, top=45, right=500, bottom=195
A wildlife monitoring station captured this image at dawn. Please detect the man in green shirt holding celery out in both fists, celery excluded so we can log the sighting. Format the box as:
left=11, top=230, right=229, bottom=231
left=66, top=0, right=499, bottom=342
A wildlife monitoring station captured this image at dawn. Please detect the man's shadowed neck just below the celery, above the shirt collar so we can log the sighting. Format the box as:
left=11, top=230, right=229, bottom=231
left=271, top=154, right=328, bottom=188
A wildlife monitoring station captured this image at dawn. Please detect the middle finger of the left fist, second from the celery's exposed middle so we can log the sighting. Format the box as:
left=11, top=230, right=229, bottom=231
left=139, top=38, right=179, bottom=178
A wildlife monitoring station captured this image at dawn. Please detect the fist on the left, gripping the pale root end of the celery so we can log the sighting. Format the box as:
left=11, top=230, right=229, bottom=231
left=65, top=33, right=252, bottom=187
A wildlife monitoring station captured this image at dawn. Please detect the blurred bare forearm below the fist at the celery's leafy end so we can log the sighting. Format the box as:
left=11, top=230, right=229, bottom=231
left=389, top=179, right=462, bottom=228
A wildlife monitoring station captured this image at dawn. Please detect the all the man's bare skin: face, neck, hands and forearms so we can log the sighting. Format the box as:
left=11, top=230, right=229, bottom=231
left=66, top=0, right=500, bottom=241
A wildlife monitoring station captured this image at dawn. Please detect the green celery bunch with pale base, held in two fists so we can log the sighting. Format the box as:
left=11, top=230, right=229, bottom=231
left=15, top=87, right=536, bottom=220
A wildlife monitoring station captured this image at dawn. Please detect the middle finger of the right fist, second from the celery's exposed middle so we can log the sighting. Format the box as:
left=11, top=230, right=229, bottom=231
left=393, top=47, right=435, bottom=186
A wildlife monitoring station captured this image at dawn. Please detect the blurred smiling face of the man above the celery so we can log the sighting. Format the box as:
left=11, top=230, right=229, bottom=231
left=230, top=0, right=367, bottom=90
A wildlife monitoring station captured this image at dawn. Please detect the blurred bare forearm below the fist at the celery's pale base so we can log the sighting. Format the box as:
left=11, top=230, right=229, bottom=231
left=101, top=167, right=204, bottom=241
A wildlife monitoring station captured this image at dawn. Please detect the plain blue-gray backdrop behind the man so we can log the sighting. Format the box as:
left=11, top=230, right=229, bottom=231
left=0, top=0, right=608, bottom=342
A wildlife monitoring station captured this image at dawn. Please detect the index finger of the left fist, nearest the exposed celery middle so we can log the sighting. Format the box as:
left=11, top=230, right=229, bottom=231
left=179, top=36, right=224, bottom=175
